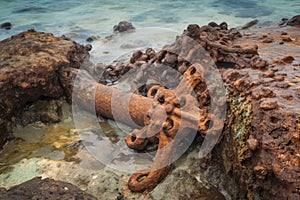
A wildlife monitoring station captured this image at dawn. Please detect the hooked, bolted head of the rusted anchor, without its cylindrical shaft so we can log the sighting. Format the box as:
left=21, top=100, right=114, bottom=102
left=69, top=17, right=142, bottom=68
left=125, top=66, right=204, bottom=192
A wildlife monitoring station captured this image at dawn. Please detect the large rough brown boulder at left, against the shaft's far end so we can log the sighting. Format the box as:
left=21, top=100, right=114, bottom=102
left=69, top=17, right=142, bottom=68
left=0, top=30, right=88, bottom=147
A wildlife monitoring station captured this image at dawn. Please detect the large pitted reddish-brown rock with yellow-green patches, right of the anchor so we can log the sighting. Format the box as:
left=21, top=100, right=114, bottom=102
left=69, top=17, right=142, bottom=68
left=220, top=27, right=300, bottom=199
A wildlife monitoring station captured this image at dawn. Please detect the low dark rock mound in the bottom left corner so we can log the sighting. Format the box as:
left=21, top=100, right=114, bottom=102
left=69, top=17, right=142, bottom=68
left=0, top=177, right=97, bottom=200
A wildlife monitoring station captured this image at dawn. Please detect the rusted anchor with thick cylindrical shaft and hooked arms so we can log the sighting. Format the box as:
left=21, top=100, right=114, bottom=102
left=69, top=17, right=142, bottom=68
left=66, top=63, right=210, bottom=192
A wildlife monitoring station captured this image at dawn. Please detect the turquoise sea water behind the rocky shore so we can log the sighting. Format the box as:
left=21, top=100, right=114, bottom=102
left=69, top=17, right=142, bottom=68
left=0, top=0, right=300, bottom=43
